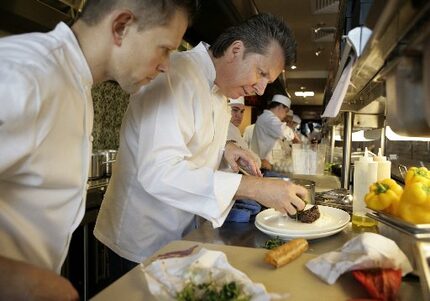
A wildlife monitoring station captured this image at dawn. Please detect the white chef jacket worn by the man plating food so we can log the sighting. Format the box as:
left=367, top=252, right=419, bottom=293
left=94, top=43, right=241, bottom=262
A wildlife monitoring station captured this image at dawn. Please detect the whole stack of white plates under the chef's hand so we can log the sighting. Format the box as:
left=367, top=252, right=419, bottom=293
left=255, top=205, right=350, bottom=240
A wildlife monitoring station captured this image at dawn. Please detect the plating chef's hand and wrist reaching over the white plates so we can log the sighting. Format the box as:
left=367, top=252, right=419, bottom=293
left=235, top=177, right=308, bottom=215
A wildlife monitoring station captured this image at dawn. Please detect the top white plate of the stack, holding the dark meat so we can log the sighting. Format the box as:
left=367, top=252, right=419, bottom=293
left=255, top=205, right=350, bottom=235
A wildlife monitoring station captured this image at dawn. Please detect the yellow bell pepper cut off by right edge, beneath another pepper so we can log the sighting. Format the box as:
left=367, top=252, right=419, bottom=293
left=399, top=182, right=430, bottom=224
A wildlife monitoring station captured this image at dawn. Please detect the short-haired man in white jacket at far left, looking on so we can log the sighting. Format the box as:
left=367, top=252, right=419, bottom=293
left=0, top=0, right=196, bottom=301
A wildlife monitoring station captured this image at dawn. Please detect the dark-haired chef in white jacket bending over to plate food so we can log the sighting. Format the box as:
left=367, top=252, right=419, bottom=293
left=94, top=14, right=307, bottom=264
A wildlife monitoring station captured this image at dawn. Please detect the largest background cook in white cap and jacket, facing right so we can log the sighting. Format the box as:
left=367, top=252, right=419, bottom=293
left=251, top=94, right=294, bottom=172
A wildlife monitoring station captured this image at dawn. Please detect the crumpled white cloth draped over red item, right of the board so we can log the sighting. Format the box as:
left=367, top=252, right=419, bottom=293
left=306, top=233, right=413, bottom=284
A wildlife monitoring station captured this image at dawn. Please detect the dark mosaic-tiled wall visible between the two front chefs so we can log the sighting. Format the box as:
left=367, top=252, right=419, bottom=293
left=92, top=82, right=129, bottom=150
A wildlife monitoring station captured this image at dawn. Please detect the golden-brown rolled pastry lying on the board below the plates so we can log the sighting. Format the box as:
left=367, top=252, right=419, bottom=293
left=264, top=238, right=309, bottom=268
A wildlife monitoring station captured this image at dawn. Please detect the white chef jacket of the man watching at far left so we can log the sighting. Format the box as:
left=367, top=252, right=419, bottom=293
left=0, top=23, right=93, bottom=272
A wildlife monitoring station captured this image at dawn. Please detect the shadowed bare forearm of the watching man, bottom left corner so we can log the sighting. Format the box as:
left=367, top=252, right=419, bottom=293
left=0, top=256, right=79, bottom=301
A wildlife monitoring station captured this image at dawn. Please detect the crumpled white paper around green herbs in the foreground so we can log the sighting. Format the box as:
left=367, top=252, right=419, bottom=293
left=141, top=248, right=286, bottom=301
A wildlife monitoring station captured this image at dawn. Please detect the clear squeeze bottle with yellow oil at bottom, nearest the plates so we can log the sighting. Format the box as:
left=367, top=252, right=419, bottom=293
left=352, top=147, right=378, bottom=227
